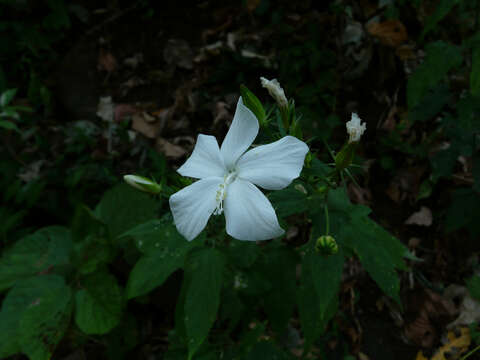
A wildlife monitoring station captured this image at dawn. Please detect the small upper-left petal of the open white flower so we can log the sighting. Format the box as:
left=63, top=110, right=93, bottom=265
left=177, top=134, right=227, bottom=179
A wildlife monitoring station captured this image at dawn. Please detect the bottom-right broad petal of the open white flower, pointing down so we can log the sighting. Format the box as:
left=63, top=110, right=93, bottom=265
left=224, top=179, right=284, bottom=241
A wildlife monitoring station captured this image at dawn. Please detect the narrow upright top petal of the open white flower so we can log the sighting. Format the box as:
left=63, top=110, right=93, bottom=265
left=220, top=97, right=258, bottom=170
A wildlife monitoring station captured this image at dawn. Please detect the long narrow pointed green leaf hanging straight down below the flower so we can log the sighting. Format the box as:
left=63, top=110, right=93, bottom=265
left=184, top=248, right=224, bottom=359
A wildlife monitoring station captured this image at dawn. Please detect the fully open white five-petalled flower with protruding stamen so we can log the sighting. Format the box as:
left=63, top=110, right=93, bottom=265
left=170, top=97, right=308, bottom=241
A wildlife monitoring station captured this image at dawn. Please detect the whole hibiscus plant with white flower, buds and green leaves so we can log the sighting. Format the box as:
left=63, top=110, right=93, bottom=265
left=0, top=78, right=412, bottom=360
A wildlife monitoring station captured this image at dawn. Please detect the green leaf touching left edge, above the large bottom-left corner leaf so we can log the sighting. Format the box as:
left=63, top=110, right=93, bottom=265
left=0, top=226, right=72, bottom=291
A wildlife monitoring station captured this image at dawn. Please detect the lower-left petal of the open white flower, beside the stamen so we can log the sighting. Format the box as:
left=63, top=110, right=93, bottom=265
left=170, top=177, right=223, bottom=241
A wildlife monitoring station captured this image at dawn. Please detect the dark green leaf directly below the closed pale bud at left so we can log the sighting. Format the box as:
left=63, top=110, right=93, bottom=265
left=95, top=184, right=158, bottom=238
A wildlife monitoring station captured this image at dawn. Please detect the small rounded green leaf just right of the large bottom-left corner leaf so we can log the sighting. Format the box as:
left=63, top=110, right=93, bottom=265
left=75, top=272, right=123, bottom=334
